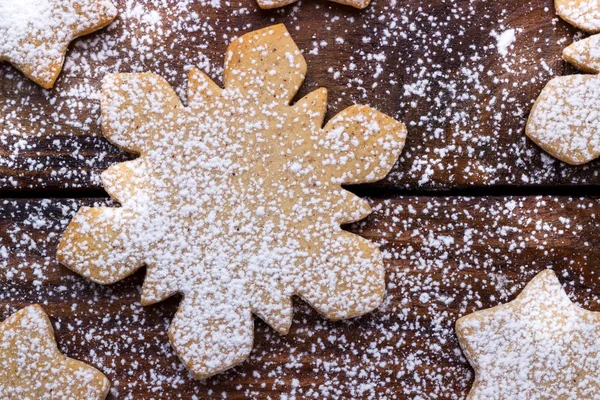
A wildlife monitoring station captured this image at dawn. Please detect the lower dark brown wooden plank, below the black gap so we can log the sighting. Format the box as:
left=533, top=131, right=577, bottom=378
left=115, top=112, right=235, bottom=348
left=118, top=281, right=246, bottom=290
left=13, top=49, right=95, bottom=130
left=0, top=197, right=600, bottom=399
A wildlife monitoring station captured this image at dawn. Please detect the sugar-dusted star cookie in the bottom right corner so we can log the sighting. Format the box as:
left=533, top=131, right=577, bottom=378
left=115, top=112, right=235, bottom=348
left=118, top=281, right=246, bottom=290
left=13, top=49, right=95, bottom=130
left=456, top=270, right=600, bottom=400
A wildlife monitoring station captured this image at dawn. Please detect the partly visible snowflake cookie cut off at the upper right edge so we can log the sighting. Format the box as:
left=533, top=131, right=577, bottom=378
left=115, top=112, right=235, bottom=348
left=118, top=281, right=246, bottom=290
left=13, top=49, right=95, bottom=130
left=526, top=0, right=600, bottom=165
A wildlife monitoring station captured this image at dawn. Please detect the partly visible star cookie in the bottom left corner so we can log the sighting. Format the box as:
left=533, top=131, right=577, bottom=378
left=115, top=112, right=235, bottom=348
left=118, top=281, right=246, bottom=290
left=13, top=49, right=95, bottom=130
left=0, top=305, right=110, bottom=400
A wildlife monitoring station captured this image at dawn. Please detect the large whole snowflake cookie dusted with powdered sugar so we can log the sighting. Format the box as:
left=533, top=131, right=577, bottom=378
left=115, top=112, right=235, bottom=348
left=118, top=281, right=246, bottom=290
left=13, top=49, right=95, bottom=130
left=58, top=25, right=406, bottom=378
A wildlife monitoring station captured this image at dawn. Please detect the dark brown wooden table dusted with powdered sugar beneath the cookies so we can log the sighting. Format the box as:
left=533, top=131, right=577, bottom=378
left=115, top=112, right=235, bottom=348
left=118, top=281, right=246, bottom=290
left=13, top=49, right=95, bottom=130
left=0, top=0, right=600, bottom=399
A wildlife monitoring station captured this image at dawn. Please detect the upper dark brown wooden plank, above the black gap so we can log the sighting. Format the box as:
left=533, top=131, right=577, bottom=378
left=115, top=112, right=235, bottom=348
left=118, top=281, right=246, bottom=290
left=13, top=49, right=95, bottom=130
left=0, top=0, right=600, bottom=189
